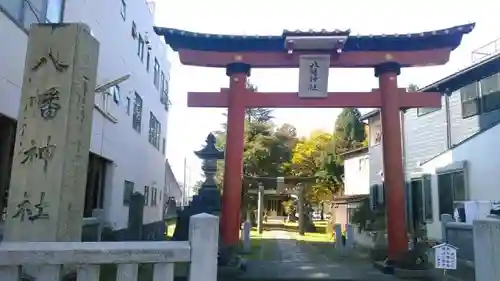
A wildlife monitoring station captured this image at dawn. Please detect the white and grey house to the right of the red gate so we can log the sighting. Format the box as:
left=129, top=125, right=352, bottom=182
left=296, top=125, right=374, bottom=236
left=363, top=39, right=500, bottom=240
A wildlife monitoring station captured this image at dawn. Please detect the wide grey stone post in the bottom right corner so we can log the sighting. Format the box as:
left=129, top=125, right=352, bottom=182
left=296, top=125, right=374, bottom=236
left=472, top=219, right=500, bottom=281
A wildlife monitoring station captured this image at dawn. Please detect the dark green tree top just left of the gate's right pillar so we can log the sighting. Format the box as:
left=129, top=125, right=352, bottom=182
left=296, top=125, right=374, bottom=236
left=334, top=108, right=365, bottom=153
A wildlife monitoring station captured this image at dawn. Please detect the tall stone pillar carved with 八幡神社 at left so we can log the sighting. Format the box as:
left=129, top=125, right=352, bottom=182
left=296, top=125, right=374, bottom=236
left=4, top=24, right=99, bottom=242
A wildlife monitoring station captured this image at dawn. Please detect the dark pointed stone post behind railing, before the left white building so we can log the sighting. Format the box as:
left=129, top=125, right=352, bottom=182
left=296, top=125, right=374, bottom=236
left=127, top=191, right=144, bottom=241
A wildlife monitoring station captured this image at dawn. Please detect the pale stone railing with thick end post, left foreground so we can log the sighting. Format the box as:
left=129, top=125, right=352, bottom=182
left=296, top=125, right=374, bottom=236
left=0, top=214, right=219, bottom=281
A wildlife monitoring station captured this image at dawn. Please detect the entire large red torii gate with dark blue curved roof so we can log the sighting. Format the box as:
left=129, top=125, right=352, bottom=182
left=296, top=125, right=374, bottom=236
left=155, top=24, right=474, bottom=261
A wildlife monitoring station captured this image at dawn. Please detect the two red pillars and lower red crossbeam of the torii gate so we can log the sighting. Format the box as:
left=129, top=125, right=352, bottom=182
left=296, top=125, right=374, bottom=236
left=188, top=62, right=441, bottom=260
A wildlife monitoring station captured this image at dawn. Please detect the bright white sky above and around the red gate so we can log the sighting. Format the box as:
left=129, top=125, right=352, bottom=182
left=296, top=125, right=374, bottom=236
left=155, top=0, right=500, bottom=191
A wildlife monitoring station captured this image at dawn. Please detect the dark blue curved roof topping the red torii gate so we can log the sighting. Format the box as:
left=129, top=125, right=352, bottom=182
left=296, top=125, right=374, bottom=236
left=154, top=23, right=475, bottom=52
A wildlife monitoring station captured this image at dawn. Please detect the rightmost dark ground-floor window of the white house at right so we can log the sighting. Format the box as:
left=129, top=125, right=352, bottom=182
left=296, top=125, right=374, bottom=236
left=437, top=170, right=467, bottom=218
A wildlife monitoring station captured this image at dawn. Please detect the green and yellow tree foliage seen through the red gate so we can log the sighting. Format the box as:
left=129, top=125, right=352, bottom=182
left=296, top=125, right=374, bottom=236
left=198, top=81, right=366, bottom=214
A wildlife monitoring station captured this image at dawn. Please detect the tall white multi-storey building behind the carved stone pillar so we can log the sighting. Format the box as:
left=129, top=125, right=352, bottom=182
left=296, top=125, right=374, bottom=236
left=0, top=0, right=178, bottom=234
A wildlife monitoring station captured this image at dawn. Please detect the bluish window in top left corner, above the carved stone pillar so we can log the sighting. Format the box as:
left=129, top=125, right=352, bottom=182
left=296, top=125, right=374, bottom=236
left=0, top=0, right=63, bottom=29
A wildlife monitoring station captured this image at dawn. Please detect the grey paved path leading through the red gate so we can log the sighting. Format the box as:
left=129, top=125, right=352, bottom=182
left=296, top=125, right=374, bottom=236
left=238, top=231, right=422, bottom=281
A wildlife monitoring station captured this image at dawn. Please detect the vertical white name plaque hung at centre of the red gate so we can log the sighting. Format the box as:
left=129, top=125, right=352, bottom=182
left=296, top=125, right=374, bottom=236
left=299, top=55, right=330, bottom=98
